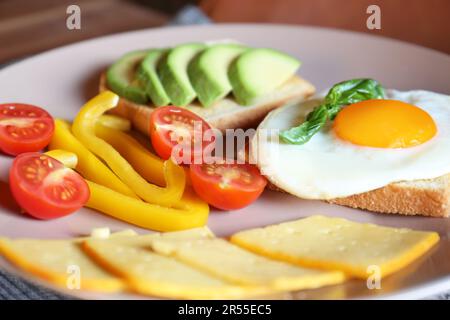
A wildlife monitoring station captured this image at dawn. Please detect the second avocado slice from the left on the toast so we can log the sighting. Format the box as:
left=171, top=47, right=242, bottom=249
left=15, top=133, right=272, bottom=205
left=137, top=49, right=170, bottom=107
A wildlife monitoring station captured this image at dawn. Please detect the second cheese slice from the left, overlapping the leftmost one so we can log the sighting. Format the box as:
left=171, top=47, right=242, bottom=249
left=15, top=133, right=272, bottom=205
left=85, top=235, right=265, bottom=299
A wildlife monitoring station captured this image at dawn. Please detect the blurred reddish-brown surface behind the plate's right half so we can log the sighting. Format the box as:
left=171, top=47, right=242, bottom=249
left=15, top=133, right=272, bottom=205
left=201, top=0, right=450, bottom=53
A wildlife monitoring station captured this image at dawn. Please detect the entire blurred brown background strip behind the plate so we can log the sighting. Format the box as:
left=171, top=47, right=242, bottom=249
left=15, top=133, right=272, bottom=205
left=0, top=0, right=450, bottom=64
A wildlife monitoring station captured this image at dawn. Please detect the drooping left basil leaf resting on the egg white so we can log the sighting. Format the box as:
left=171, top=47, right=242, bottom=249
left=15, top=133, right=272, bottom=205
left=280, top=104, right=328, bottom=144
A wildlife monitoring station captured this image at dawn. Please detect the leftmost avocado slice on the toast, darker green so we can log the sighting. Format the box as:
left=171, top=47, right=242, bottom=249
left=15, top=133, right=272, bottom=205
left=106, top=51, right=148, bottom=104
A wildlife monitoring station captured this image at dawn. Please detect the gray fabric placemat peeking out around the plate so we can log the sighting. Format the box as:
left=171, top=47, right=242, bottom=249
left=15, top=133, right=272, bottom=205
left=0, top=6, right=450, bottom=300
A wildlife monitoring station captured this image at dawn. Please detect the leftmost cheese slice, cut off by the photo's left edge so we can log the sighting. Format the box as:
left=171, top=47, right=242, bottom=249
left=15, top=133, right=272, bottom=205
left=0, top=230, right=136, bottom=292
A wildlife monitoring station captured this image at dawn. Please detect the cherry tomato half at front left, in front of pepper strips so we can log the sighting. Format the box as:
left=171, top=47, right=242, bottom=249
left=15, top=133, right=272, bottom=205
left=9, top=152, right=90, bottom=220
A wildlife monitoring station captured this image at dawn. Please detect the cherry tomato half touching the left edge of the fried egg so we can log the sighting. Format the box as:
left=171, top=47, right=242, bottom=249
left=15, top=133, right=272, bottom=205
left=190, top=161, right=267, bottom=210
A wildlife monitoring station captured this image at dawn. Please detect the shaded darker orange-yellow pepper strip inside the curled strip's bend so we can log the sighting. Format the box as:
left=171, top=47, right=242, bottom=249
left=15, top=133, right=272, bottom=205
left=95, top=124, right=166, bottom=187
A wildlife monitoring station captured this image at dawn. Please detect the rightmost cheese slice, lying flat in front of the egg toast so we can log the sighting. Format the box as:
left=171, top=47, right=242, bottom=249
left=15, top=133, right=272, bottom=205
left=231, top=216, right=439, bottom=279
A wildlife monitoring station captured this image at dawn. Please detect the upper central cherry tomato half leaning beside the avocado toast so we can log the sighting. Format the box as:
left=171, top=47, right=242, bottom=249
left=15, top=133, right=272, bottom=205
left=150, top=106, right=215, bottom=164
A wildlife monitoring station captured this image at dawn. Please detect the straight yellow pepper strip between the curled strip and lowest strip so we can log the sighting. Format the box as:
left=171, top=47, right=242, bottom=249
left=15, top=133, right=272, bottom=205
left=48, top=119, right=138, bottom=198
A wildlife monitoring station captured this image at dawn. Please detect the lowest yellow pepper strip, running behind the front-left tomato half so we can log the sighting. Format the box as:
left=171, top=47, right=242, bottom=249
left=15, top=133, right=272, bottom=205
left=46, top=150, right=209, bottom=231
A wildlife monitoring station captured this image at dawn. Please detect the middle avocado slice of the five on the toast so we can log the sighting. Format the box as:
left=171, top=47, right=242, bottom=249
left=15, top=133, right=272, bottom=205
left=158, top=43, right=205, bottom=106
